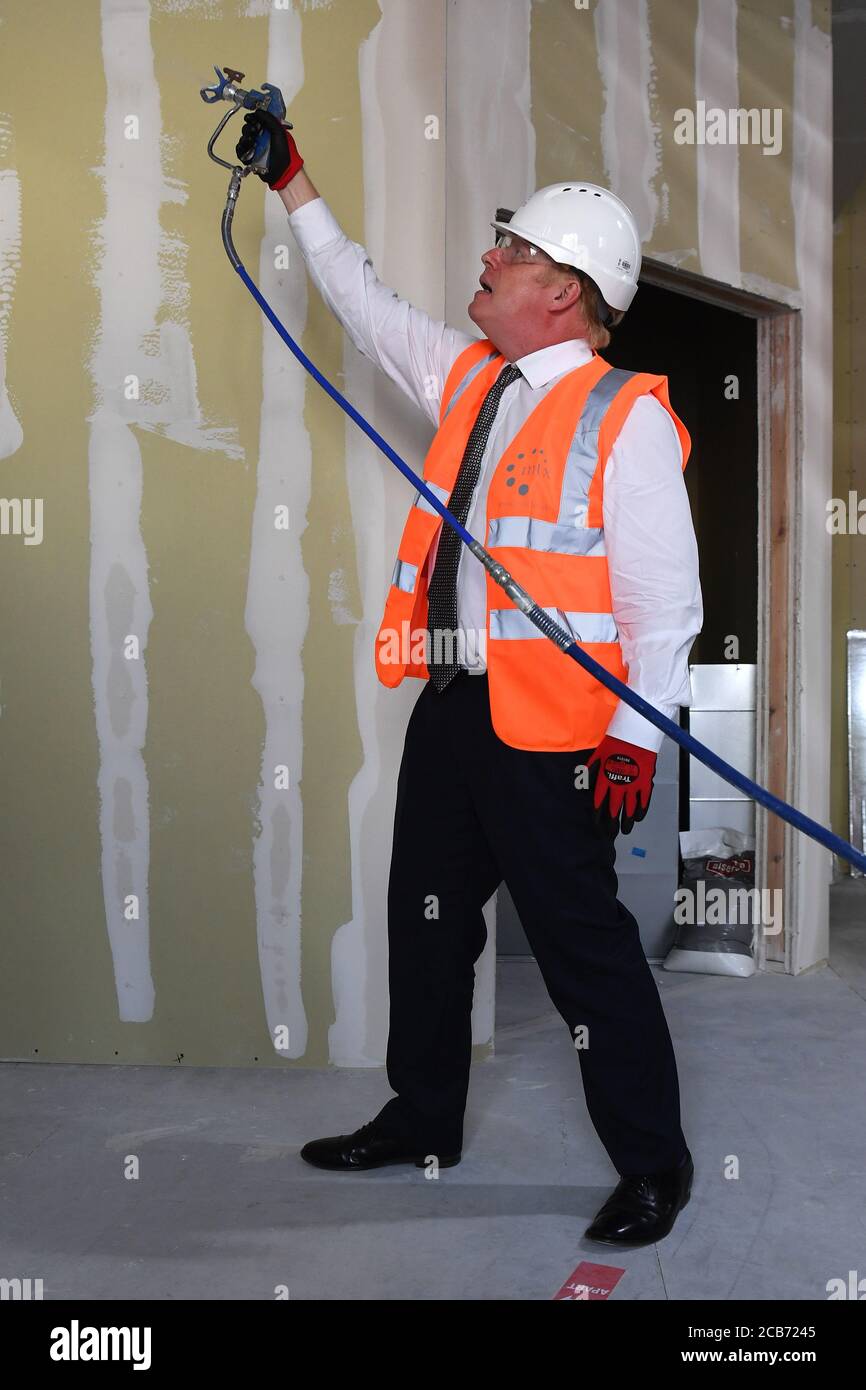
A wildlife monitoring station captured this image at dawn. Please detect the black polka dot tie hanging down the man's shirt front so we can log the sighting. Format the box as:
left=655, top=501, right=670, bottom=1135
left=427, top=363, right=520, bottom=691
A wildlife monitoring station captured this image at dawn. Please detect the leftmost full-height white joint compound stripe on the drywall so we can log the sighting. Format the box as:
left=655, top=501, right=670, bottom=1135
left=89, top=0, right=163, bottom=1023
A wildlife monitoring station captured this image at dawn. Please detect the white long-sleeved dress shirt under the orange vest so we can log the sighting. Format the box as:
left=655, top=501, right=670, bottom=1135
left=288, top=197, right=703, bottom=752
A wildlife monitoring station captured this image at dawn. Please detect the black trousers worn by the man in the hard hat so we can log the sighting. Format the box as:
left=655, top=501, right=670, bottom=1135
left=377, top=671, right=687, bottom=1176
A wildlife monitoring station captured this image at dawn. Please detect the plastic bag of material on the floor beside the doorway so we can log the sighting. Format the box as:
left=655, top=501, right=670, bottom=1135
left=663, top=826, right=760, bottom=977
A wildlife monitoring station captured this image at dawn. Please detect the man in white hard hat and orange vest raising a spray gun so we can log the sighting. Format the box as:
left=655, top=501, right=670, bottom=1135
left=238, top=102, right=702, bottom=1245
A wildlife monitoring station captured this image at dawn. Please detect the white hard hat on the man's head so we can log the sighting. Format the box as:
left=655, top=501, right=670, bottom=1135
left=491, top=181, right=641, bottom=310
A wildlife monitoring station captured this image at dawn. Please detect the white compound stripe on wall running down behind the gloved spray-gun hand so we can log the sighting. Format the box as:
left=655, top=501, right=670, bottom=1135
left=244, top=10, right=313, bottom=1058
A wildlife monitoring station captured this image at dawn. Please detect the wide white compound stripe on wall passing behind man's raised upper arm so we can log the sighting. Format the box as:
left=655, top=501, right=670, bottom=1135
left=328, top=0, right=445, bottom=1066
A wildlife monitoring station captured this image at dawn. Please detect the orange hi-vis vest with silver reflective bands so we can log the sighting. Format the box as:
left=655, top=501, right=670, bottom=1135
left=375, top=338, right=691, bottom=752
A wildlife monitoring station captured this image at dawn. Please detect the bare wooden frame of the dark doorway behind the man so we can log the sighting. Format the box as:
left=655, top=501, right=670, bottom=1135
left=641, top=257, right=802, bottom=970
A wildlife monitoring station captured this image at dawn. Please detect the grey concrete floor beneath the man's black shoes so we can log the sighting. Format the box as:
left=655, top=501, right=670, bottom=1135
left=0, top=880, right=866, bottom=1301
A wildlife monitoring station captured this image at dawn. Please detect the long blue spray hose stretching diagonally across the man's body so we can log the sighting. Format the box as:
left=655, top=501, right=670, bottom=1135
left=231, top=265, right=866, bottom=873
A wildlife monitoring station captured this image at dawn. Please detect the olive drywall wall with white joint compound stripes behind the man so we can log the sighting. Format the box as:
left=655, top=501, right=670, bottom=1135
left=0, top=0, right=831, bottom=1068
